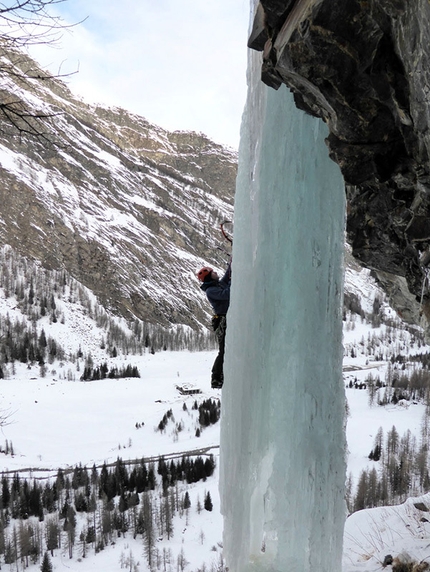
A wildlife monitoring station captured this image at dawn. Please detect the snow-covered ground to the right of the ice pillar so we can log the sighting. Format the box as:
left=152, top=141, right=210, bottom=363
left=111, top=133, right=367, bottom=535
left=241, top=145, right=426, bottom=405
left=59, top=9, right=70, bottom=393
left=342, top=365, right=430, bottom=572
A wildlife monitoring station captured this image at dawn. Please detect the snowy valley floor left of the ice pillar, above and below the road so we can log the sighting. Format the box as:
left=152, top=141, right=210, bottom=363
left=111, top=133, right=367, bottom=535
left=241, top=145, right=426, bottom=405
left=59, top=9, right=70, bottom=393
left=0, top=352, right=222, bottom=572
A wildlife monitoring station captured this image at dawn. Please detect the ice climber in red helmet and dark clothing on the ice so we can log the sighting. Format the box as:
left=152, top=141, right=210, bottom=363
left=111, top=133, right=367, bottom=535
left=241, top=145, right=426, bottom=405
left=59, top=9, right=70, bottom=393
left=197, top=262, right=231, bottom=389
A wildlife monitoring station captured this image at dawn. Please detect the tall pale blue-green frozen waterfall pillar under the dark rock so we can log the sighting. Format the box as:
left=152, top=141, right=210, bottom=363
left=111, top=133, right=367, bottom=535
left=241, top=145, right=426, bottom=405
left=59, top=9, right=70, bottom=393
left=220, top=34, right=345, bottom=572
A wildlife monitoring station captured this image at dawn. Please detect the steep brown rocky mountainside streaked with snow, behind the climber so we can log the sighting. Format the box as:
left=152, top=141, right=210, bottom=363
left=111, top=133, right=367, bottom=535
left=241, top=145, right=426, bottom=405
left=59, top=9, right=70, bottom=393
left=0, top=50, right=237, bottom=329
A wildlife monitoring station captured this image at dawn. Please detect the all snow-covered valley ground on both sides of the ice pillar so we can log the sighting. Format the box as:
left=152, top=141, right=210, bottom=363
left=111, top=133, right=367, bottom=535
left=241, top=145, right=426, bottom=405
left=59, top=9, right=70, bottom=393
left=0, top=266, right=430, bottom=572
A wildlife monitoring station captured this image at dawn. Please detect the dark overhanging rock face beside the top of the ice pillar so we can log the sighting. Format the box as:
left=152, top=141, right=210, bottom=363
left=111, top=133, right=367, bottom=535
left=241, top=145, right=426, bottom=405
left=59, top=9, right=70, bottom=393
left=248, top=0, right=430, bottom=327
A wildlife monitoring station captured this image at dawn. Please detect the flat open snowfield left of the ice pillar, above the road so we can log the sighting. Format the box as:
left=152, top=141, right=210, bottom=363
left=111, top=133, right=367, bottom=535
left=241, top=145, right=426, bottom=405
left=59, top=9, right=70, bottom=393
left=0, top=352, right=219, bottom=470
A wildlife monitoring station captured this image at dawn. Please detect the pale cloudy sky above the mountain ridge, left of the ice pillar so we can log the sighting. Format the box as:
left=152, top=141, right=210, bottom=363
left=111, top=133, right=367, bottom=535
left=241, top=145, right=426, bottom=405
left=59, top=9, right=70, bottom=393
left=26, top=0, right=250, bottom=149
